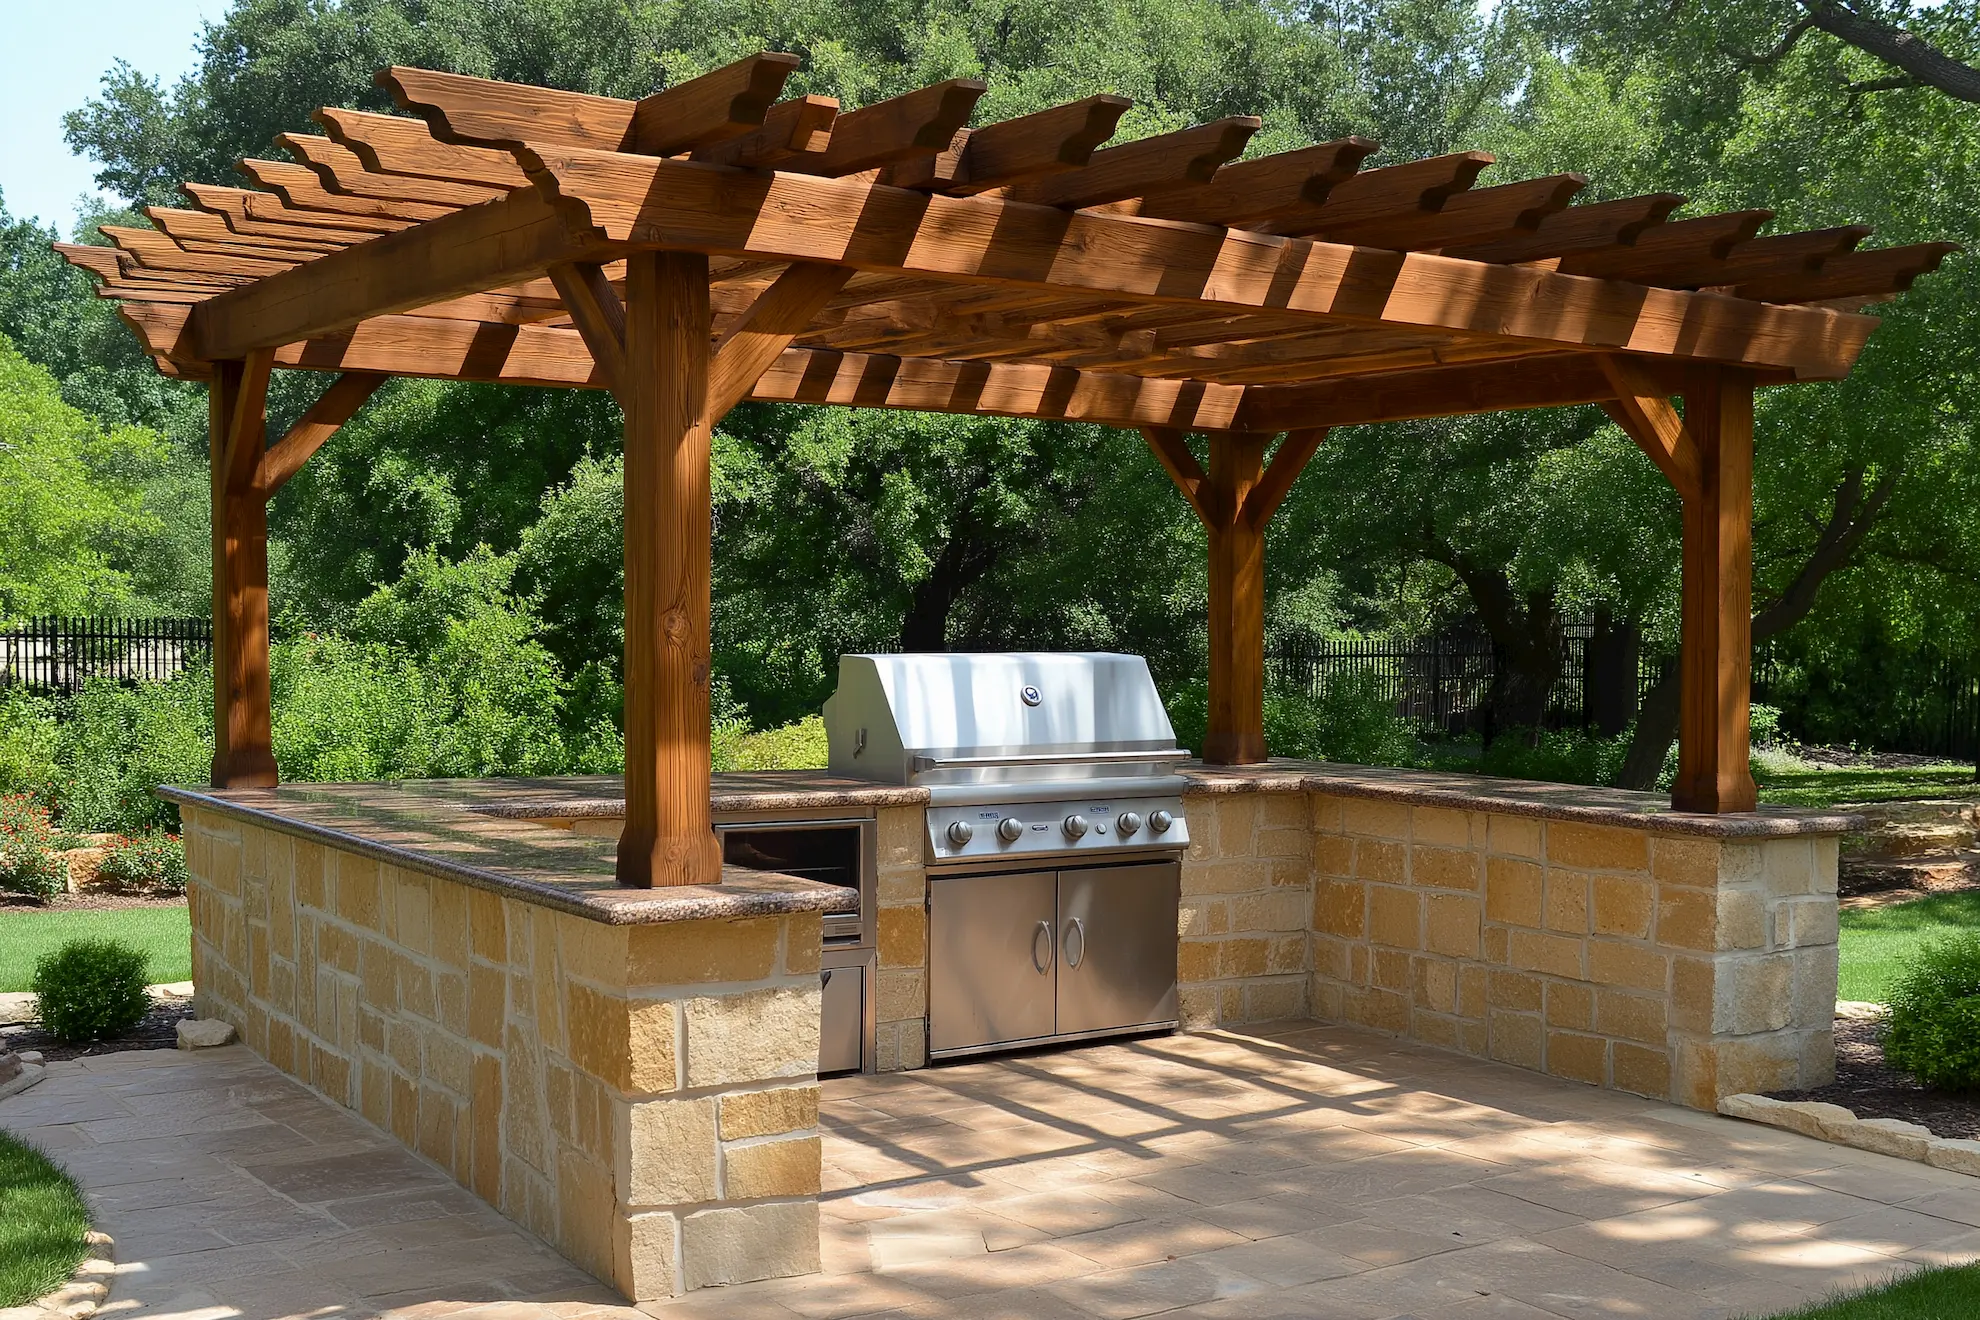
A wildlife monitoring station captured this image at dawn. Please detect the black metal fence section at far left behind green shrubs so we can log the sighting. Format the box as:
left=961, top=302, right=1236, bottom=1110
left=0, top=617, right=214, bottom=693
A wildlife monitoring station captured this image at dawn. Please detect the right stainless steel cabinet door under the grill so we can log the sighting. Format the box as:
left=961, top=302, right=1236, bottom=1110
left=1057, top=861, right=1182, bottom=1035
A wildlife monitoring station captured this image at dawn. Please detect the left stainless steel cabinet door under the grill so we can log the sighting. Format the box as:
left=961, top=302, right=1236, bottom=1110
left=929, top=871, right=1057, bottom=1053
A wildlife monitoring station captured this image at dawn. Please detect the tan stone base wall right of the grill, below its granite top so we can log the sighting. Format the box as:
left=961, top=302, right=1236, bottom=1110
left=1180, top=790, right=1837, bottom=1110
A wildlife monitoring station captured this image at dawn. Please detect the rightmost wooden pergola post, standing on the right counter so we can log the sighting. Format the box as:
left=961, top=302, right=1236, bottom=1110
left=1671, top=368, right=1756, bottom=811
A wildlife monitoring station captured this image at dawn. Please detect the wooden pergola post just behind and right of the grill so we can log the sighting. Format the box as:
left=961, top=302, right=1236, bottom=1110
left=1204, top=431, right=1271, bottom=766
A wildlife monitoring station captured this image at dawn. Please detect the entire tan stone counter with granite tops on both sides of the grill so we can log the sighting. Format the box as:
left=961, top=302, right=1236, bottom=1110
left=162, top=762, right=1855, bottom=1300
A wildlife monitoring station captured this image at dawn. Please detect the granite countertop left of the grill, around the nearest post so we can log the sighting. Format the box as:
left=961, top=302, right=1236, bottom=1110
left=158, top=772, right=906, bottom=924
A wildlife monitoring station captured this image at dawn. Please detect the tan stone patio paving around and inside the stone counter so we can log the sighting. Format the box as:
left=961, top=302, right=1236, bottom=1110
left=0, top=1023, right=1980, bottom=1320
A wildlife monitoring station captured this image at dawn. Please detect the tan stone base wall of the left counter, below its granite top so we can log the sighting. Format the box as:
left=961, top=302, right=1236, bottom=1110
left=184, top=807, right=820, bottom=1300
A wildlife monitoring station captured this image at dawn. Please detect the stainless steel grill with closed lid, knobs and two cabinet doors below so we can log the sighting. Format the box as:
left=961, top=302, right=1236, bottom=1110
left=826, top=653, right=1190, bottom=1057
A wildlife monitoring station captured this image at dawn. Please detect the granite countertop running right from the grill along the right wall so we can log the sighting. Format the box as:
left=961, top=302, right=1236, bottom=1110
left=1182, top=760, right=1863, bottom=839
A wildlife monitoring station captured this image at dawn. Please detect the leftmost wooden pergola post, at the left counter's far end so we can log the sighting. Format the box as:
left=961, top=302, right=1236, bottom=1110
left=206, top=352, right=275, bottom=788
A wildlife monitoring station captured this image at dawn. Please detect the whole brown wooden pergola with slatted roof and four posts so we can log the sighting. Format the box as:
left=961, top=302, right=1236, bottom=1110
left=57, top=53, right=1954, bottom=885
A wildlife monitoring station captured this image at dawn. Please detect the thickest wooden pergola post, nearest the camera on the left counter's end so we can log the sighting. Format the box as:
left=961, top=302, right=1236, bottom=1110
left=618, top=251, right=721, bottom=889
